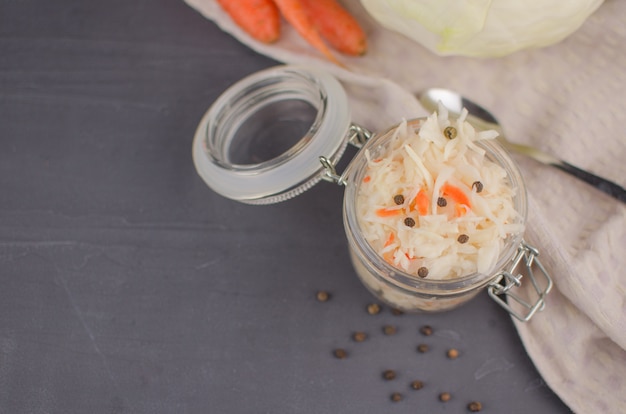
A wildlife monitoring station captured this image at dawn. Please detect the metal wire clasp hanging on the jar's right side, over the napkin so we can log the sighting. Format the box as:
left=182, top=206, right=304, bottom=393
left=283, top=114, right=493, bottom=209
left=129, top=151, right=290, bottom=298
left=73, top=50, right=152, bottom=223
left=487, top=240, right=552, bottom=322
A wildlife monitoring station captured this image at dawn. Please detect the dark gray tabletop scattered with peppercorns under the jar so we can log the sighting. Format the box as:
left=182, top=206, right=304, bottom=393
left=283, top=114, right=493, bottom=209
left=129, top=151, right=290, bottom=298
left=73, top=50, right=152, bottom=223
left=0, top=0, right=568, bottom=414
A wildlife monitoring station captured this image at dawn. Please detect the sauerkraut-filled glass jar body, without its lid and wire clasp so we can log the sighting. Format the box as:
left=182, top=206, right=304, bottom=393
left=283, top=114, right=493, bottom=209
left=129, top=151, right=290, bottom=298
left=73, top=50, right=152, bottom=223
left=344, top=107, right=526, bottom=311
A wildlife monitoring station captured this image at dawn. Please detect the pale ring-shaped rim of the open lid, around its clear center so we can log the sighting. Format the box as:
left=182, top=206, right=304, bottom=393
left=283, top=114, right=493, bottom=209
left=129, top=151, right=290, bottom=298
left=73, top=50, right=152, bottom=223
left=192, top=65, right=351, bottom=204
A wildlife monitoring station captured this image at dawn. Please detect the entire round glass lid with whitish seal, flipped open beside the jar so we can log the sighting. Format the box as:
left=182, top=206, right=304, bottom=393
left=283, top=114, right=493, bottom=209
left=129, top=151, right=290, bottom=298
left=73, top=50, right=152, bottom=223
left=193, top=66, right=351, bottom=204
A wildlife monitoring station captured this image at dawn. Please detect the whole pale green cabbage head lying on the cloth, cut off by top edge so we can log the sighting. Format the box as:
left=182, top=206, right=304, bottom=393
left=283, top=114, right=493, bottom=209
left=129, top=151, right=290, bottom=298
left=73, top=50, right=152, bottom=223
left=361, top=0, right=603, bottom=57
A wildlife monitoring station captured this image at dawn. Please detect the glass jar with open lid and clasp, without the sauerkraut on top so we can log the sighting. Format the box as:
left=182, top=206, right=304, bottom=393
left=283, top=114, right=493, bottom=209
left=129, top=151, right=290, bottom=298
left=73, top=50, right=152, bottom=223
left=193, top=66, right=552, bottom=321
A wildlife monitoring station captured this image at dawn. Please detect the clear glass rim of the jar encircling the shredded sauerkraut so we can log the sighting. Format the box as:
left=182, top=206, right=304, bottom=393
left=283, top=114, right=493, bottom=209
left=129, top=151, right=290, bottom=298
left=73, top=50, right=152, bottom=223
left=343, top=118, right=528, bottom=295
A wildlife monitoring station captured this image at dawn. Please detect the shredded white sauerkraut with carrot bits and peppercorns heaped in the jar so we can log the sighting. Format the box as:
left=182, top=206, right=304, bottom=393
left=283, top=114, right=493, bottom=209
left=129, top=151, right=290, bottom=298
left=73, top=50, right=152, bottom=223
left=356, top=106, right=524, bottom=280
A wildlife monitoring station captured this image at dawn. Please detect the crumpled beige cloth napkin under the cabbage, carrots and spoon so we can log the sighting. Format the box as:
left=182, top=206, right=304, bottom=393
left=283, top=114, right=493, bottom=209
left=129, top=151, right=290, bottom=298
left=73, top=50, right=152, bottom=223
left=185, top=0, right=626, bottom=413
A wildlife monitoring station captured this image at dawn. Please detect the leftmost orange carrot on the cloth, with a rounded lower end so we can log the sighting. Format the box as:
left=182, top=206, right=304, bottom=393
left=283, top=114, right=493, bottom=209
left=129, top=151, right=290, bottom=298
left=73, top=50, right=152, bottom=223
left=217, top=0, right=280, bottom=43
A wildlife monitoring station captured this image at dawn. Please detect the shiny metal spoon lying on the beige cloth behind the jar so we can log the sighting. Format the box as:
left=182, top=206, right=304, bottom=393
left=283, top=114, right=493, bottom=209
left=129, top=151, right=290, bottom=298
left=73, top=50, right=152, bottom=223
left=418, top=88, right=626, bottom=203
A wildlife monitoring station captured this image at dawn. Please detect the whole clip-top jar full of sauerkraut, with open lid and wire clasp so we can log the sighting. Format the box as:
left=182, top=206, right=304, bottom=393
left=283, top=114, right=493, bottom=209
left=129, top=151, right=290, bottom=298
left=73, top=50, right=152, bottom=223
left=193, top=65, right=552, bottom=321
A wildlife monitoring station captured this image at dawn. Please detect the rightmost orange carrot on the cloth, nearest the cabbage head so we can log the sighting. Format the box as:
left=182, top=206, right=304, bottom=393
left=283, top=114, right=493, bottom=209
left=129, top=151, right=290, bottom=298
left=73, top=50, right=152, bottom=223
left=302, top=0, right=367, bottom=56
